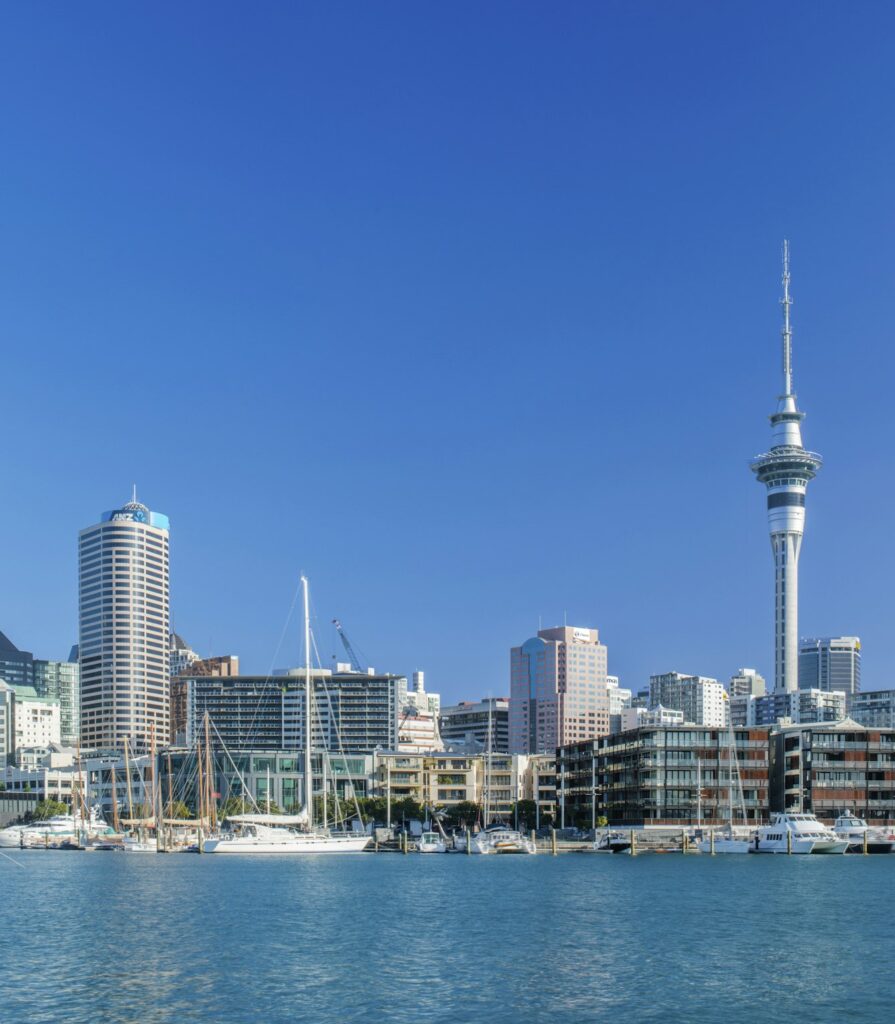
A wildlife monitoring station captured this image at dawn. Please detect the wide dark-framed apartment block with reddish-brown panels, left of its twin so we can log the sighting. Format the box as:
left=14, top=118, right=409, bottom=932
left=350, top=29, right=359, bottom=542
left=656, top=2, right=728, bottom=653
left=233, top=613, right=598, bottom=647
left=557, top=726, right=769, bottom=827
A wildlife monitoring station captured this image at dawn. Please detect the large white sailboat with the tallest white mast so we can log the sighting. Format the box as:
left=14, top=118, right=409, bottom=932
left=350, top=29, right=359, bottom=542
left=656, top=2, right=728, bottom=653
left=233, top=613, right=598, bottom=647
left=205, top=577, right=370, bottom=855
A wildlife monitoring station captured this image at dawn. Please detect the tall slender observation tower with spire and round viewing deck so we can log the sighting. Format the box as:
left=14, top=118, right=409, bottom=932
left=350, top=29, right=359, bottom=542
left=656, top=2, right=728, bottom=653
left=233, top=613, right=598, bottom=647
left=752, top=242, right=822, bottom=693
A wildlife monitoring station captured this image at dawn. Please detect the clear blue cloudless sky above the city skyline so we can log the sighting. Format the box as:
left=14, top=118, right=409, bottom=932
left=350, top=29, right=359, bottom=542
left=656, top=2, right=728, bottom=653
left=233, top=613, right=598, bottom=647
left=0, top=0, right=895, bottom=699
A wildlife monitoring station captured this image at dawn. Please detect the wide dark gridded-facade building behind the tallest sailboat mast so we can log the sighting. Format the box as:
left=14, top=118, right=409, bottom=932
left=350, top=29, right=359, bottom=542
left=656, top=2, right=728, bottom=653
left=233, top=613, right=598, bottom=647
left=171, top=669, right=407, bottom=754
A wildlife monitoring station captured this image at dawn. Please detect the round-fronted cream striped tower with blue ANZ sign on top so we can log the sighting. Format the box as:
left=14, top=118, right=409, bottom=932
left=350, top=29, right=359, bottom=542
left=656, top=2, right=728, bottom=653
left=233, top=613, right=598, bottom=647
left=79, top=488, right=170, bottom=751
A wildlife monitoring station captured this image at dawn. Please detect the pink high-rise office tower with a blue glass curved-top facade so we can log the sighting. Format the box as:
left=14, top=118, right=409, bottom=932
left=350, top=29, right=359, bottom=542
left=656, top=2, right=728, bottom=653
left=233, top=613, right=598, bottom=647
left=510, top=626, right=609, bottom=754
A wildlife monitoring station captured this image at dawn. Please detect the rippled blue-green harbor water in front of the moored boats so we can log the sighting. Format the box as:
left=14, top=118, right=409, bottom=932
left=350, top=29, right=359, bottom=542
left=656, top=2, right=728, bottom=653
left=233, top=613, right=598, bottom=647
left=0, top=851, right=895, bottom=1024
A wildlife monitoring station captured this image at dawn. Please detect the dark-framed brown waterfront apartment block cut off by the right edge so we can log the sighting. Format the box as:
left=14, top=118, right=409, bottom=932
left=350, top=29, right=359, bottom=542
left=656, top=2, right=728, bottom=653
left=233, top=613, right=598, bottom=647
left=770, top=719, right=895, bottom=824
